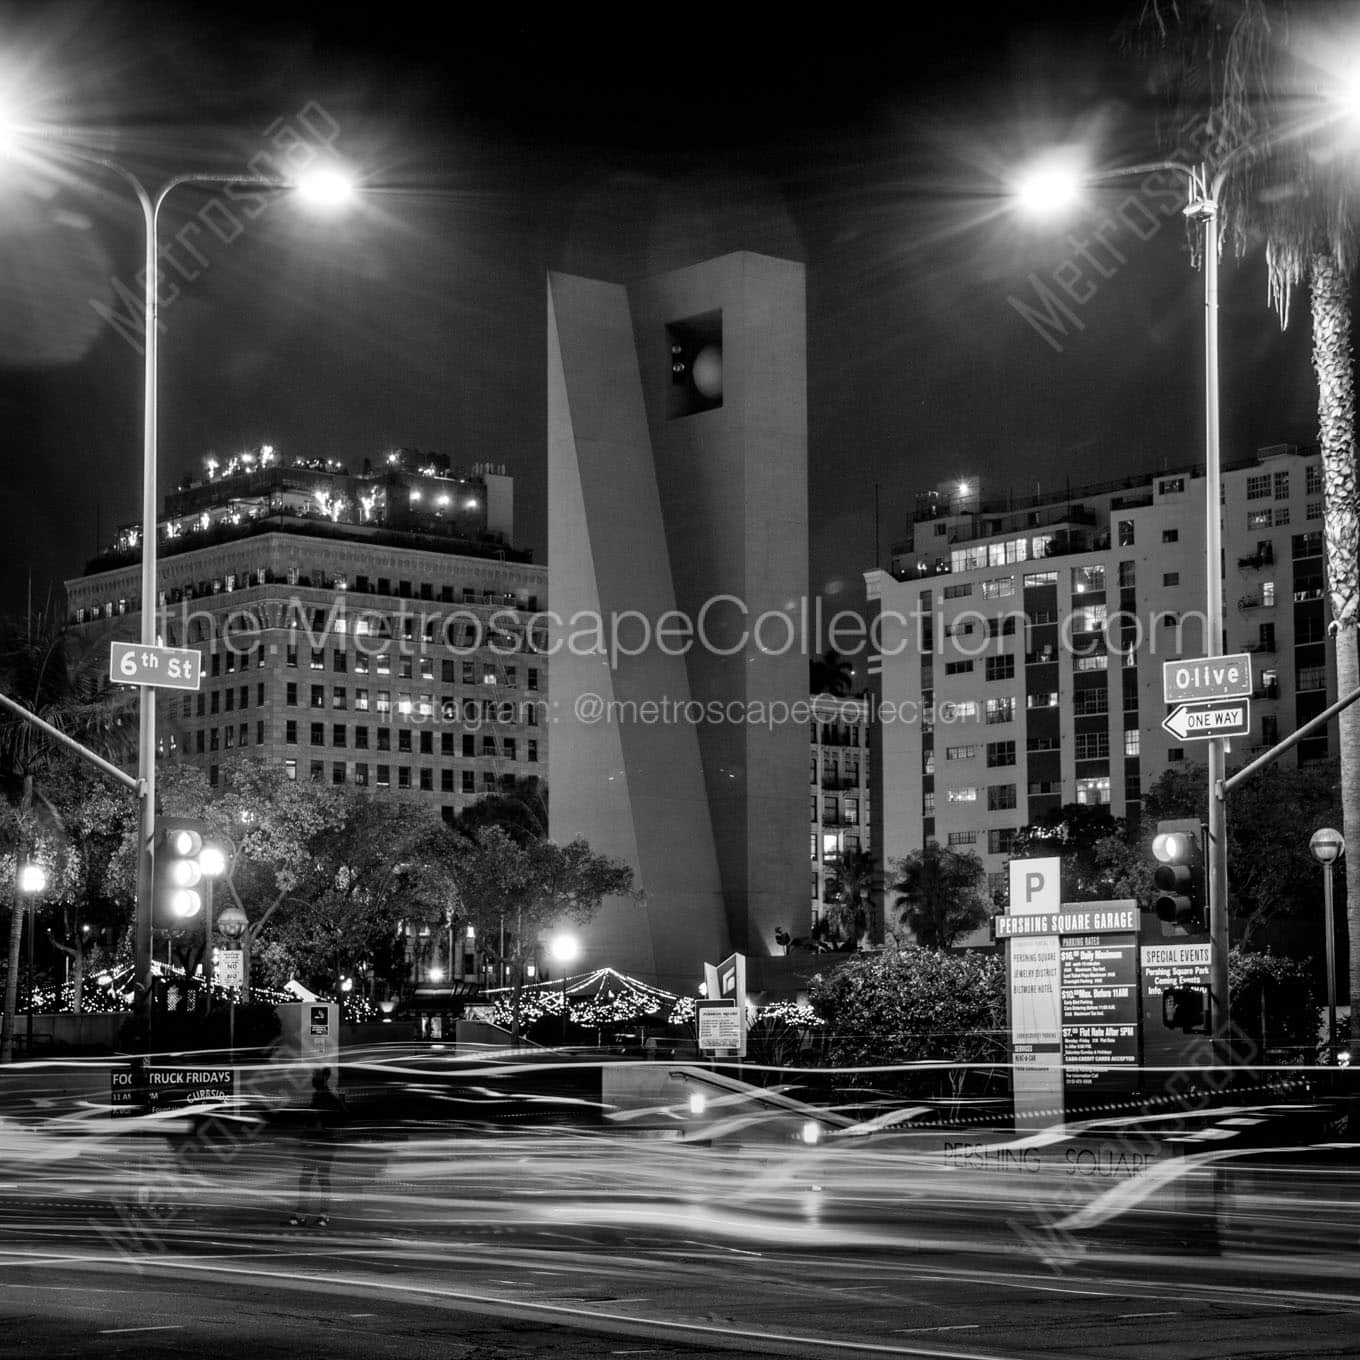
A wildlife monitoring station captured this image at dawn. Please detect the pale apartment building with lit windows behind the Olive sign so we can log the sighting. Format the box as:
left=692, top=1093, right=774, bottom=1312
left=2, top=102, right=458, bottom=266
left=865, top=445, right=1336, bottom=913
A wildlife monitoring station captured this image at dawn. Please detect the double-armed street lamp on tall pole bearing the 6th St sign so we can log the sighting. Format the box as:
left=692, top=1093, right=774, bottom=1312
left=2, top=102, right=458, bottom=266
left=0, top=118, right=354, bottom=1032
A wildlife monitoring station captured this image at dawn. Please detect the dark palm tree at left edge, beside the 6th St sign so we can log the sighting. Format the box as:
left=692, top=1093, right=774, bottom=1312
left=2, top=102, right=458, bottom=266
left=0, top=607, right=136, bottom=1062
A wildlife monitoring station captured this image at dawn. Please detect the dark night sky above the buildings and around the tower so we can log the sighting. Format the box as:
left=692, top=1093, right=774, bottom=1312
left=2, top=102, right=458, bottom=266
left=0, top=3, right=1315, bottom=647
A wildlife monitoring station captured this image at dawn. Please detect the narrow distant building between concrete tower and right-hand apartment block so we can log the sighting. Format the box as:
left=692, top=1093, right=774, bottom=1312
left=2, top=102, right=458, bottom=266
left=796, top=694, right=874, bottom=934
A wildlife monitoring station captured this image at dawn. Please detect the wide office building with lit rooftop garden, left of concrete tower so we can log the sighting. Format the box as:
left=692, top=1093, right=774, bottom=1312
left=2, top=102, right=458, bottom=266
left=67, top=446, right=548, bottom=820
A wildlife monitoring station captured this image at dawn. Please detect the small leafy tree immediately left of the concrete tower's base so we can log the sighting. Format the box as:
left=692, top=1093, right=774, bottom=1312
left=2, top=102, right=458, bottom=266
left=452, top=827, right=634, bottom=1039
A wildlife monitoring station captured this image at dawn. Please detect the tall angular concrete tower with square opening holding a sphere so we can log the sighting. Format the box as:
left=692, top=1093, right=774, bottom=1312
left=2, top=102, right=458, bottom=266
left=548, top=253, right=808, bottom=990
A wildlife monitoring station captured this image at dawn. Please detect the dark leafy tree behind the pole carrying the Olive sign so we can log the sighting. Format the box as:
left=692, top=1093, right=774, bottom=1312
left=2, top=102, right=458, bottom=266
left=1144, top=764, right=1349, bottom=946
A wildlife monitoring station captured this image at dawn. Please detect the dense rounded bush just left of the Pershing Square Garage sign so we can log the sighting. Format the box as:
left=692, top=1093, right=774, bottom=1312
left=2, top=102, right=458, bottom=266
left=808, top=945, right=1008, bottom=1092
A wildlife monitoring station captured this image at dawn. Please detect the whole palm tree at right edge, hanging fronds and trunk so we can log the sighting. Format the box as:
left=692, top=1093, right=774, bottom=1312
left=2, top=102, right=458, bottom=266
left=1137, top=0, right=1360, bottom=1043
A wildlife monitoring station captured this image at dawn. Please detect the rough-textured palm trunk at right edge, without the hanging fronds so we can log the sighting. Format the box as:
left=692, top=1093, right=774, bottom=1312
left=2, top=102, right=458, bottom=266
left=1310, top=252, right=1360, bottom=1043
